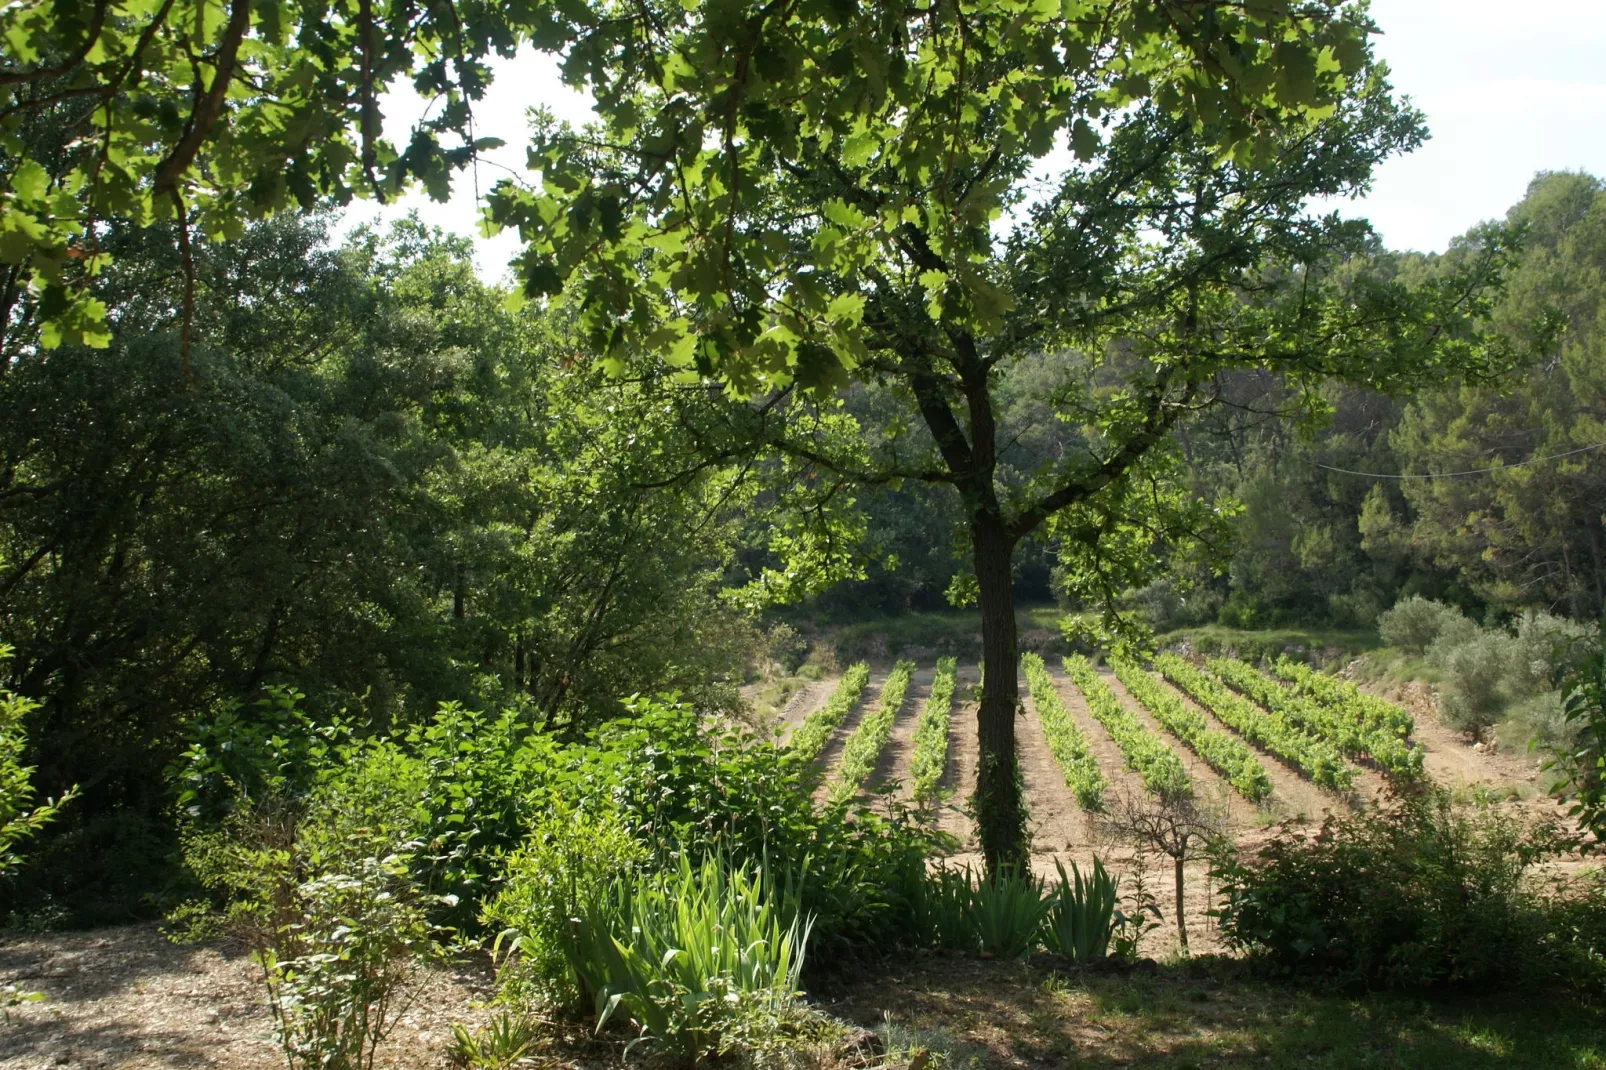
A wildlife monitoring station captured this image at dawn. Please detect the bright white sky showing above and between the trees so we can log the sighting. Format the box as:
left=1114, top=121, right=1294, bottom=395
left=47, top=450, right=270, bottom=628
left=347, top=0, right=1606, bottom=278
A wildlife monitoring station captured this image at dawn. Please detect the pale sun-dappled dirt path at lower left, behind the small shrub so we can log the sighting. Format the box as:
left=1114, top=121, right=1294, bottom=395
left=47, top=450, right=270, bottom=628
left=0, top=924, right=493, bottom=1070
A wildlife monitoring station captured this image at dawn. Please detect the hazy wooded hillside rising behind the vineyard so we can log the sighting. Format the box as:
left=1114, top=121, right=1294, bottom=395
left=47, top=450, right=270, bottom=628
left=841, top=174, right=1606, bottom=631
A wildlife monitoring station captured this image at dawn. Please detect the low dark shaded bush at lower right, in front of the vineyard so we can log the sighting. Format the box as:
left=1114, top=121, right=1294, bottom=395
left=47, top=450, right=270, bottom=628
left=1214, top=792, right=1555, bottom=988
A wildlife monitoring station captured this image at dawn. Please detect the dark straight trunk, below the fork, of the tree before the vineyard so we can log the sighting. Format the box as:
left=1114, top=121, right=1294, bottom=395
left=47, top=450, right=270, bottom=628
left=970, top=511, right=1029, bottom=876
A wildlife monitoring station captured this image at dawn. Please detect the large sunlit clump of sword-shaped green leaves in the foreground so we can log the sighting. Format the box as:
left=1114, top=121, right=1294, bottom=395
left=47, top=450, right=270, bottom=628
left=569, top=856, right=811, bottom=1060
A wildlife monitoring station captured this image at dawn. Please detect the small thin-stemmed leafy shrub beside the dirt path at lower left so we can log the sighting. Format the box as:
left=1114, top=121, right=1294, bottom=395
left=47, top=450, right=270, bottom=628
left=185, top=739, right=435, bottom=1068
